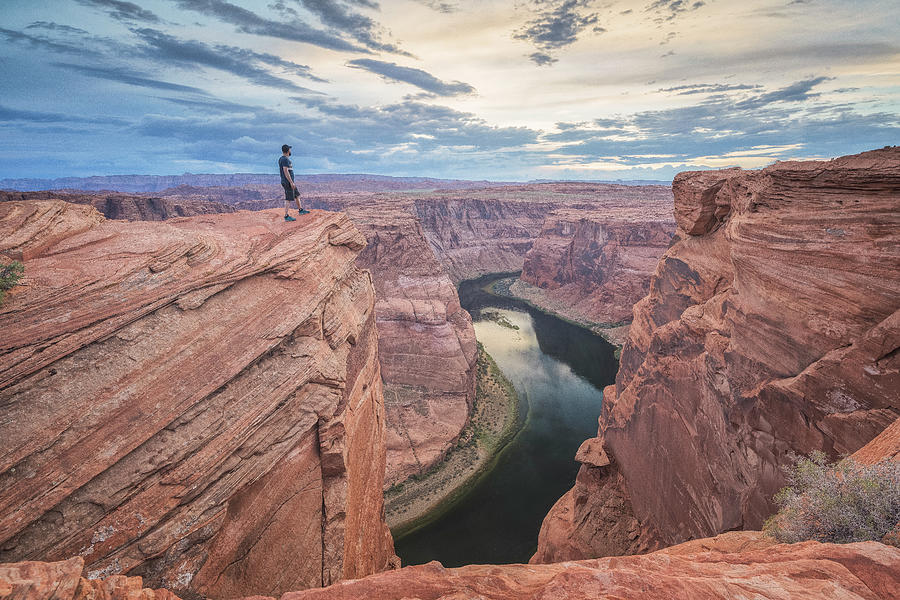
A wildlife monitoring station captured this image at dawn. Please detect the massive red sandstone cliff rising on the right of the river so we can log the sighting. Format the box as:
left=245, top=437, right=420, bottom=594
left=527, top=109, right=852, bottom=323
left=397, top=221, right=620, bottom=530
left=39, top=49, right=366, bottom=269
left=535, top=148, right=900, bottom=560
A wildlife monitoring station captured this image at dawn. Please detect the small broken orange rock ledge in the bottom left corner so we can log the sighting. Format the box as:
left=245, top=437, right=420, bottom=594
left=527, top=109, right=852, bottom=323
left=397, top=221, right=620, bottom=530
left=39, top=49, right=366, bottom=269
left=0, top=556, right=179, bottom=600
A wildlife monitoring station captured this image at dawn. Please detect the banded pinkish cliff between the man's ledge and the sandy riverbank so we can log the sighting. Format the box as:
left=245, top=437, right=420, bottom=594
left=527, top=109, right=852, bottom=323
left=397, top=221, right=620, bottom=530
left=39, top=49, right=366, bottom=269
left=348, top=205, right=477, bottom=487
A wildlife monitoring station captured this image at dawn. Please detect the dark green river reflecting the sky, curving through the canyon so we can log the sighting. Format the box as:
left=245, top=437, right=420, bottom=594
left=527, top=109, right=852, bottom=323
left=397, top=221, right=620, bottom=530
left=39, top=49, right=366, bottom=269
left=395, top=276, right=618, bottom=567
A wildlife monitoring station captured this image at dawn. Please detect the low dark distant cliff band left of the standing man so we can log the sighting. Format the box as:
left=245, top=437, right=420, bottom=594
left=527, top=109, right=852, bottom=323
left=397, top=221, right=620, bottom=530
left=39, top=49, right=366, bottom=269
left=0, top=191, right=235, bottom=221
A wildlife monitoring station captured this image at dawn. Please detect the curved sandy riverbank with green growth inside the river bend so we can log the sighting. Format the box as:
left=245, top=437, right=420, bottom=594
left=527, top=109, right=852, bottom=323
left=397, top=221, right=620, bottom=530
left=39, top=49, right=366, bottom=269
left=384, top=344, right=524, bottom=538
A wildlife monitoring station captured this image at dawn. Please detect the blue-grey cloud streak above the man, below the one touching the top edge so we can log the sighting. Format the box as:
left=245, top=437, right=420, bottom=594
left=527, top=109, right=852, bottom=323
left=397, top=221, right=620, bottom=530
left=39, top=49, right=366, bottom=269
left=132, top=28, right=323, bottom=92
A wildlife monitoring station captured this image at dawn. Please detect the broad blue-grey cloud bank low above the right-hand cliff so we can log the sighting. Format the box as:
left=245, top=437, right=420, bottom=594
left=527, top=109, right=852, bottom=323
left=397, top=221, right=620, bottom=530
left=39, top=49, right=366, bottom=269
left=542, top=77, right=900, bottom=166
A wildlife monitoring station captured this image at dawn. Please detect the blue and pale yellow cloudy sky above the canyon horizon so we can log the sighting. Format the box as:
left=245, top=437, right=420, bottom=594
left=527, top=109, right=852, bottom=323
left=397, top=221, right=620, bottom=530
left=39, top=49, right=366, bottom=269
left=0, top=0, right=900, bottom=181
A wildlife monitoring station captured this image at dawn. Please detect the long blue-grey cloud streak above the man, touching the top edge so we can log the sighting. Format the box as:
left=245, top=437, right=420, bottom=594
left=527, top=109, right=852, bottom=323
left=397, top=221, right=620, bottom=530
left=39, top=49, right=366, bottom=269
left=170, top=0, right=371, bottom=54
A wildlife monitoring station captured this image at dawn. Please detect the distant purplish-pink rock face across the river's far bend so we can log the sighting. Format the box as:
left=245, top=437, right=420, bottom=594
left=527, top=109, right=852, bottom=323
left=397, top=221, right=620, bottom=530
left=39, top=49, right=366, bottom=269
left=514, top=209, right=675, bottom=332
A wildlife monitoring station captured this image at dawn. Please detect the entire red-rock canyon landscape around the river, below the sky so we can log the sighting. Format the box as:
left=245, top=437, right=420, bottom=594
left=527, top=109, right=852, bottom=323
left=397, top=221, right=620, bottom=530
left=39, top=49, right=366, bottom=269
left=0, top=148, right=900, bottom=600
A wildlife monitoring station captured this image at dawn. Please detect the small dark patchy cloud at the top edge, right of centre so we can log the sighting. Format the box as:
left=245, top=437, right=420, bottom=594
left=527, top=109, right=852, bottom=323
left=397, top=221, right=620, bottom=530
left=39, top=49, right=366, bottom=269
left=513, top=0, right=606, bottom=65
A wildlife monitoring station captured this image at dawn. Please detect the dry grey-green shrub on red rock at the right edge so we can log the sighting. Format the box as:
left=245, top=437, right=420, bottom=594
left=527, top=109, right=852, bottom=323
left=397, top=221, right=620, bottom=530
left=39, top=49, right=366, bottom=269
left=763, top=452, right=900, bottom=544
